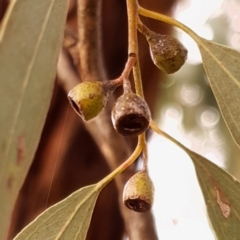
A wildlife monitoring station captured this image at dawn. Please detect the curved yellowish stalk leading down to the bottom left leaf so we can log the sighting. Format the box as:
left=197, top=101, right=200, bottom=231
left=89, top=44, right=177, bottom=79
left=98, top=142, right=144, bottom=186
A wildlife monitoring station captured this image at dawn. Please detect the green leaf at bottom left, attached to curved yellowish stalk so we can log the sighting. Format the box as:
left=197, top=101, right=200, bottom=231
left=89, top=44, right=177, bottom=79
left=14, top=184, right=103, bottom=240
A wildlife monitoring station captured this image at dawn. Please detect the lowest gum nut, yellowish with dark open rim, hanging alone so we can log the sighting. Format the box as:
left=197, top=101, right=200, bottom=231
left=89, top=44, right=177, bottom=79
left=123, top=171, right=154, bottom=212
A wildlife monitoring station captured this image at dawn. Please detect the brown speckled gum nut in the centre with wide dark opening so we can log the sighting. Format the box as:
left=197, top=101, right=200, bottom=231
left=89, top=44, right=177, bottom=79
left=112, top=92, right=150, bottom=136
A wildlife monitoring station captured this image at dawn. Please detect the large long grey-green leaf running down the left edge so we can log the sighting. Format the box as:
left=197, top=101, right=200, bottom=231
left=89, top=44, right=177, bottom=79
left=0, top=0, right=68, bottom=239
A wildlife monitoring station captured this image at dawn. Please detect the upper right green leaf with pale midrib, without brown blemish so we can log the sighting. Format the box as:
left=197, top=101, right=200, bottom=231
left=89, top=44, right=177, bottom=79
left=197, top=37, right=240, bottom=147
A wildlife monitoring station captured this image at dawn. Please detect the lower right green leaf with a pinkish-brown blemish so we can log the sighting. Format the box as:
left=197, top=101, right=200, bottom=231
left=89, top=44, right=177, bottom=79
left=188, top=148, right=240, bottom=240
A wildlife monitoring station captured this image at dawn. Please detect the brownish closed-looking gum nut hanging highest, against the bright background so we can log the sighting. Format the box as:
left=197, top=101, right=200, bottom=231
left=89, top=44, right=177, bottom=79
left=147, top=32, right=188, bottom=74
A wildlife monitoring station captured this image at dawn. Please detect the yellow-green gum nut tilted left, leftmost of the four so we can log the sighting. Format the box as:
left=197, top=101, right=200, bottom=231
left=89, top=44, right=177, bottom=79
left=68, top=81, right=107, bottom=121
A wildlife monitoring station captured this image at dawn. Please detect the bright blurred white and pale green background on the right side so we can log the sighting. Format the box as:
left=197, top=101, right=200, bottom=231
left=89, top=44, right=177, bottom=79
left=149, top=0, right=240, bottom=240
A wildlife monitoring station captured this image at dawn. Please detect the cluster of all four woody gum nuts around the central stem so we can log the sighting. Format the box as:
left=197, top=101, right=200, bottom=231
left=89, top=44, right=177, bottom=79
left=68, top=26, right=187, bottom=212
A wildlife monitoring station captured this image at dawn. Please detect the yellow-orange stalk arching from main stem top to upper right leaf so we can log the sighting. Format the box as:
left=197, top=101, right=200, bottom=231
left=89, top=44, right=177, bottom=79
left=138, top=6, right=200, bottom=44
